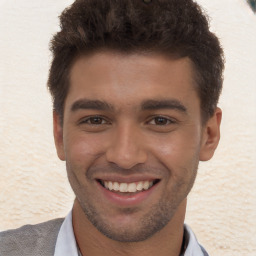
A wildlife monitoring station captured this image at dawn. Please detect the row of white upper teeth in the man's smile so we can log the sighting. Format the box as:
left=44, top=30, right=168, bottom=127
left=102, top=181, right=156, bottom=193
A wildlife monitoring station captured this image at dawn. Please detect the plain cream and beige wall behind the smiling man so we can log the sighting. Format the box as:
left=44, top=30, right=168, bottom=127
left=0, top=0, right=256, bottom=256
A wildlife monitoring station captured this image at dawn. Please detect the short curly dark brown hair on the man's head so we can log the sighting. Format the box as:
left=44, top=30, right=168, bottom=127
left=48, top=0, right=224, bottom=120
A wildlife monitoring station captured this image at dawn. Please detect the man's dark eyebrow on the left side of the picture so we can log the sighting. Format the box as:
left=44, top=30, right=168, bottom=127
left=71, top=99, right=114, bottom=112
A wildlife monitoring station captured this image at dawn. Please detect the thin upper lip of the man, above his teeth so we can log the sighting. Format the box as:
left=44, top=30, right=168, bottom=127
left=95, top=174, right=160, bottom=183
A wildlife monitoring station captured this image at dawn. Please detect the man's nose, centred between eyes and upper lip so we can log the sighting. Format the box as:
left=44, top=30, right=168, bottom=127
left=106, top=125, right=147, bottom=169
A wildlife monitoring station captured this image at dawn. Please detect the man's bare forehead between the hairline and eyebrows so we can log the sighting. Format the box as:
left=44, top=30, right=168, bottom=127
left=66, top=52, right=197, bottom=111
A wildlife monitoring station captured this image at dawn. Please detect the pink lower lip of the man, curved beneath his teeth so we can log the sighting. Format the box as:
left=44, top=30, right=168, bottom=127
left=97, top=182, right=159, bottom=207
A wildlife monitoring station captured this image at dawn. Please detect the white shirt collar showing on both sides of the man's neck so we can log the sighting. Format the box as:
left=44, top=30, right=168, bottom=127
left=54, top=211, right=208, bottom=256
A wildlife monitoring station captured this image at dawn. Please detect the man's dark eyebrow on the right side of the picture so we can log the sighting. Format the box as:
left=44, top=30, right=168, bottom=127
left=141, top=99, right=187, bottom=113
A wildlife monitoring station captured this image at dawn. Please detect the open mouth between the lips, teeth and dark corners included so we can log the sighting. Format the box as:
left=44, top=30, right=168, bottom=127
left=97, top=179, right=160, bottom=194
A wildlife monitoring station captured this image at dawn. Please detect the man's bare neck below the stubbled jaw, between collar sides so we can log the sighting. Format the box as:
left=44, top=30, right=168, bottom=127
left=73, top=199, right=186, bottom=256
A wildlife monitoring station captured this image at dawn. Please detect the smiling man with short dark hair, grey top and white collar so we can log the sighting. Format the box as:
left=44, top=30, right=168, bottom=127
left=0, top=0, right=223, bottom=256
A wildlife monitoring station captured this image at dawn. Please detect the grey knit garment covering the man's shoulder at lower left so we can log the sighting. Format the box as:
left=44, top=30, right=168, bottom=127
left=0, top=219, right=64, bottom=256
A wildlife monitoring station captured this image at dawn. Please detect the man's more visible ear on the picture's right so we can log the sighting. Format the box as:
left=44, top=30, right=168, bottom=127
left=199, top=108, right=222, bottom=161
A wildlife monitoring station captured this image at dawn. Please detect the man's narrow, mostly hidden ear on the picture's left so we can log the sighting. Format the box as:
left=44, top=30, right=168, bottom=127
left=53, top=110, right=65, bottom=161
